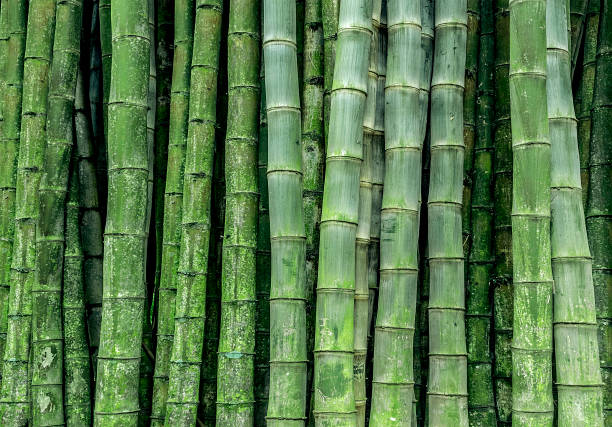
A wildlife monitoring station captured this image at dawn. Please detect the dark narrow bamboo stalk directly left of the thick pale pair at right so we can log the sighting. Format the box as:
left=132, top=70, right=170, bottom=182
left=491, top=0, right=513, bottom=426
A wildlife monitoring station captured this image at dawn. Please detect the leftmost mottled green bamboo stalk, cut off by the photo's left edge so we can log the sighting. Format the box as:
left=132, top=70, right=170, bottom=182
left=0, top=0, right=18, bottom=394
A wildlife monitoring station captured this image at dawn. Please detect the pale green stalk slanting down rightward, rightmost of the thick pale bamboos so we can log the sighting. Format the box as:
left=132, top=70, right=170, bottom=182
left=546, top=0, right=604, bottom=426
